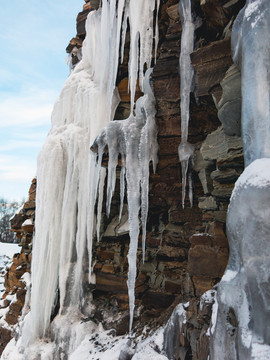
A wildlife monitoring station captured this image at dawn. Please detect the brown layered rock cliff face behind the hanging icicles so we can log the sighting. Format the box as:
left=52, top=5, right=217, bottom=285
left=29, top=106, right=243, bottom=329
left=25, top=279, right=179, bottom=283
left=1, top=0, right=247, bottom=360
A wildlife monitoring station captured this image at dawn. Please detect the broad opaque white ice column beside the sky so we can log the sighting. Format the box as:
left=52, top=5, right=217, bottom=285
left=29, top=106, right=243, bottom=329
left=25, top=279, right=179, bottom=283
left=23, top=1, right=123, bottom=345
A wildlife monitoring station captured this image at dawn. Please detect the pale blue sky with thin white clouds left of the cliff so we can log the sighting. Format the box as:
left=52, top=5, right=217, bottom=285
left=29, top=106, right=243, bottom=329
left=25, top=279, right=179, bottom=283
left=0, top=0, right=84, bottom=200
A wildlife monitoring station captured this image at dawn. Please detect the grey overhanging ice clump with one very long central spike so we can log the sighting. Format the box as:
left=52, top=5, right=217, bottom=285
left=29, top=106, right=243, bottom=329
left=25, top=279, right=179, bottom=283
left=93, top=69, right=158, bottom=331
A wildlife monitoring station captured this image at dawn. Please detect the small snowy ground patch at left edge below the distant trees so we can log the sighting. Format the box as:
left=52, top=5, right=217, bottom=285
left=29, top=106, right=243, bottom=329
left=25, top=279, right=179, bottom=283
left=0, top=242, right=21, bottom=298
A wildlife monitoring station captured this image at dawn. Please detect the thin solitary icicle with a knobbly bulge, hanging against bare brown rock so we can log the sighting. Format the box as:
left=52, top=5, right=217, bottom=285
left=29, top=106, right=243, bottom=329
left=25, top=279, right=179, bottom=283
left=178, top=0, right=195, bottom=208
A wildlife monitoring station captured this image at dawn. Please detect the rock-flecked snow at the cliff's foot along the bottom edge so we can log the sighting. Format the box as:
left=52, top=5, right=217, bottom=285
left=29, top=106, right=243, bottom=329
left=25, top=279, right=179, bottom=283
left=1, top=315, right=168, bottom=360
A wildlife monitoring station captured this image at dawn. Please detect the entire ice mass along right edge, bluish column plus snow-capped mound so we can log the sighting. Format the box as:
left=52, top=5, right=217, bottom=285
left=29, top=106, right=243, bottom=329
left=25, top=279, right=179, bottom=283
left=211, top=0, right=270, bottom=360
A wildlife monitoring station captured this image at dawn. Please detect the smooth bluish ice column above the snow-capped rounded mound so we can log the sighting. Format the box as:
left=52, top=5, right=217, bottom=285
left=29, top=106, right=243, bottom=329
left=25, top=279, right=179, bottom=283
left=232, top=0, right=270, bottom=166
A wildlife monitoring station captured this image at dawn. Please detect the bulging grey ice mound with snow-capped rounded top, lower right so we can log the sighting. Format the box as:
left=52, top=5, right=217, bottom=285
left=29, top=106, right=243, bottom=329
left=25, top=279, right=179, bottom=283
left=211, top=159, right=270, bottom=360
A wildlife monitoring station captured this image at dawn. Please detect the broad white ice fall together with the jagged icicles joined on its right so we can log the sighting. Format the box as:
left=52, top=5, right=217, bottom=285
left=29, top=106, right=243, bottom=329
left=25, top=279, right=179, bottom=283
left=19, top=0, right=159, bottom=346
